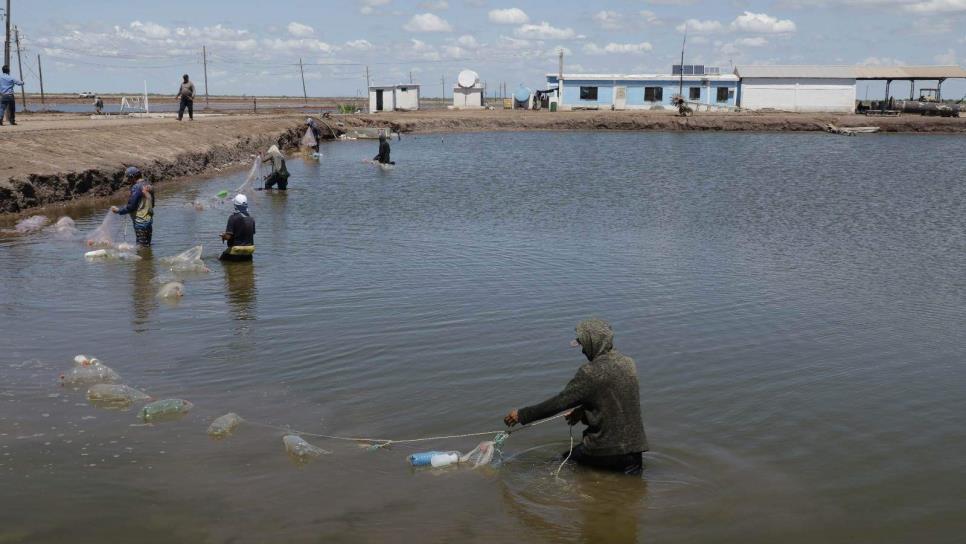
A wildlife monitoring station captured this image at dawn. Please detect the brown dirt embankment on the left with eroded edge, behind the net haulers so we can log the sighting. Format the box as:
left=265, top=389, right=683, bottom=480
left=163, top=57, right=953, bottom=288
left=0, top=116, right=314, bottom=214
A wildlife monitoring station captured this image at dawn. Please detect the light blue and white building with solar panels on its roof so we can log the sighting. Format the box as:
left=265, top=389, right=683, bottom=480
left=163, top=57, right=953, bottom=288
left=547, top=65, right=739, bottom=111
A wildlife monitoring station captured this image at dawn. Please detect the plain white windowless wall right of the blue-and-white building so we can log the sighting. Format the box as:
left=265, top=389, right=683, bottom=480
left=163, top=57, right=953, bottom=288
left=741, top=78, right=855, bottom=113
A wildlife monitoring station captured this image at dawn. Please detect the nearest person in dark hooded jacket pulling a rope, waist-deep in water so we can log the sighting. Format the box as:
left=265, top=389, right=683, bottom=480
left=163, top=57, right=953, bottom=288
left=503, top=319, right=647, bottom=474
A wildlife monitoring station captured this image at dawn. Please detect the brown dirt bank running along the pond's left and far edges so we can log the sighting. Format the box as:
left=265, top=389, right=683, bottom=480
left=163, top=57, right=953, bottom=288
left=0, top=110, right=966, bottom=214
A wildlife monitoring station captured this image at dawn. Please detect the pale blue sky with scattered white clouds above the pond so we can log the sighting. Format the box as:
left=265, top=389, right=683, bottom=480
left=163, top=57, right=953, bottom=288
left=11, top=0, right=966, bottom=98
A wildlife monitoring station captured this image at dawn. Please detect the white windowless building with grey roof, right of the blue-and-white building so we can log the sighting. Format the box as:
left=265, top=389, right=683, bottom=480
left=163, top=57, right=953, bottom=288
left=735, top=66, right=856, bottom=113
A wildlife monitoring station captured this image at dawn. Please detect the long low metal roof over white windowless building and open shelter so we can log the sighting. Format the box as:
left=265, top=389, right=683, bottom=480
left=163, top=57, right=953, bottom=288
left=735, top=65, right=966, bottom=79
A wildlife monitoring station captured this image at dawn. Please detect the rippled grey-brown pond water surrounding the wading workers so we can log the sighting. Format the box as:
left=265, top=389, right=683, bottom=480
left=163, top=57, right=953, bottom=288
left=0, top=133, right=966, bottom=543
